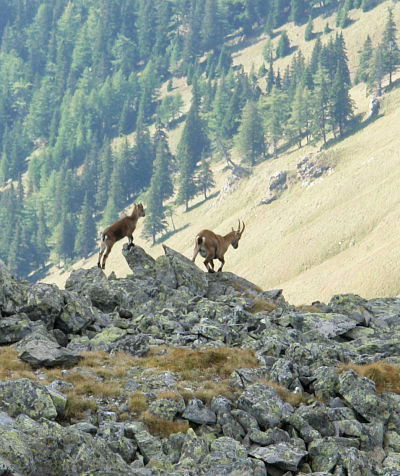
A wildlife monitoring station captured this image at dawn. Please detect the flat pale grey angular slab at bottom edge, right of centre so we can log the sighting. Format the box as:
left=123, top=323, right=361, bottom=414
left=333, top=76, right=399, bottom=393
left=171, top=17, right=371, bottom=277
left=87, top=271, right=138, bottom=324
left=249, top=442, right=308, bottom=471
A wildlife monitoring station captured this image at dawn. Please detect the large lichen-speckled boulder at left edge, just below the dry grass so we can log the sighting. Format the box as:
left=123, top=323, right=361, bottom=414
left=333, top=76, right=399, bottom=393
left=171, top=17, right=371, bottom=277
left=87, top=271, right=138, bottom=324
left=0, top=378, right=57, bottom=420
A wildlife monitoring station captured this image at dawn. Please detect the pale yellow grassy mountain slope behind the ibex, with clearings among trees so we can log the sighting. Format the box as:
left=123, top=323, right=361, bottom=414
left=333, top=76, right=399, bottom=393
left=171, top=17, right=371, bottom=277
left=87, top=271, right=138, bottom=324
left=45, top=2, right=400, bottom=304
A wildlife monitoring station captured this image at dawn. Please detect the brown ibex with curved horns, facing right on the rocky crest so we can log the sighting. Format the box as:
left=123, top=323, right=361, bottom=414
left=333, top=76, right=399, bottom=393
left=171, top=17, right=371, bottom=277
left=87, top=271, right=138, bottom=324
left=192, top=220, right=245, bottom=273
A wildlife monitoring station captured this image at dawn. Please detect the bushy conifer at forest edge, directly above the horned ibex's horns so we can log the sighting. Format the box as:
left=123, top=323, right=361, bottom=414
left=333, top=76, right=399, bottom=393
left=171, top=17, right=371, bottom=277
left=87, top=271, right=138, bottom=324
left=236, top=100, right=265, bottom=166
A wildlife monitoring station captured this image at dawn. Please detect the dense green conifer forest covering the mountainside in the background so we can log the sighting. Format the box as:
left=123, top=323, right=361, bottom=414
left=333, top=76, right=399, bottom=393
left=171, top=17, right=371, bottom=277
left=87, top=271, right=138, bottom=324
left=0, top=0, right=400, bottom=279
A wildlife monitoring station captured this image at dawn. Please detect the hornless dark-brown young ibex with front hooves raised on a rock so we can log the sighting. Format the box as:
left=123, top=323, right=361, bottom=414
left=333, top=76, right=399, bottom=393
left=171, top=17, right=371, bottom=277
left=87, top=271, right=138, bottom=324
left=97, top=203, right=145, bottom=269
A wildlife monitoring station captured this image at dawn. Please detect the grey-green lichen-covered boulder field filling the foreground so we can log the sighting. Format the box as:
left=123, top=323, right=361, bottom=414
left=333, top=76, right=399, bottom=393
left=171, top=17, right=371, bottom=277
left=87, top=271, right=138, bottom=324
left=0, top=246, right=400, bottom=476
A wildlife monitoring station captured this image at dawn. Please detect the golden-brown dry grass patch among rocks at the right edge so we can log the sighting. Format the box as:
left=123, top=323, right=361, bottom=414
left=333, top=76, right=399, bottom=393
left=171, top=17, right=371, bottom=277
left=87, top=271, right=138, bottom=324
left=338, top=361, right=400, bottom=395
